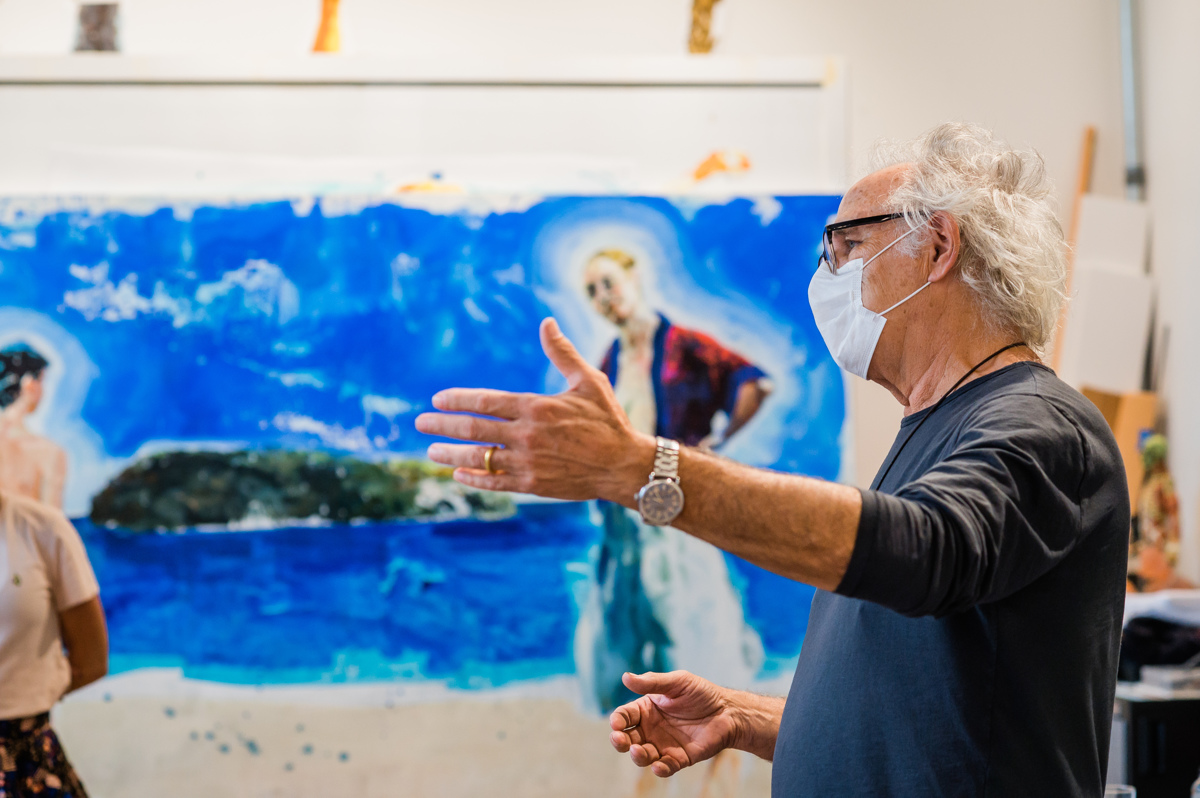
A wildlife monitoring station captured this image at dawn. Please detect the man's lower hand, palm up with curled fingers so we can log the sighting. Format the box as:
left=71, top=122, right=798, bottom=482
left=608, top=671, right=738, bottom=779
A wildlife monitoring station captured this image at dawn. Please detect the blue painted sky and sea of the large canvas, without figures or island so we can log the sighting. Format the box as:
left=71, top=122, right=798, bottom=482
left=0, top=196, right=848, bottom=689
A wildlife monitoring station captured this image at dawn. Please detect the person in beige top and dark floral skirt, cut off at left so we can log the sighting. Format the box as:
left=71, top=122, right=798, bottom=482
left=0, top=492, right=108, bottom=798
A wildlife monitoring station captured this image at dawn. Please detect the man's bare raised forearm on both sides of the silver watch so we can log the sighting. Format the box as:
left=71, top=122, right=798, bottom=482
left=598, top=436, right=863, bottom=590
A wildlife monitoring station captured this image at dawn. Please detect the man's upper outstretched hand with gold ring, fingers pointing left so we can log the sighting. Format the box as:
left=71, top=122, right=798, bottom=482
left=416, top=319, right=654, bottom=505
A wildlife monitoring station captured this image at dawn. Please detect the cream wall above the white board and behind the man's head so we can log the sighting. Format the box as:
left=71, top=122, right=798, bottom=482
left=0, top=0, right=1123, bottom=484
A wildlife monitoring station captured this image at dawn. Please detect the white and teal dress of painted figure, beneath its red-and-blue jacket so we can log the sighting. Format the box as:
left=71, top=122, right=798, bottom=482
left=575, top=328, right=763, bottom=712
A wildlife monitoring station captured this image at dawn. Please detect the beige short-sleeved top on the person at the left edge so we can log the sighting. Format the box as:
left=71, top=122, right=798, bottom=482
left=0, top=493, right=100, bottom=720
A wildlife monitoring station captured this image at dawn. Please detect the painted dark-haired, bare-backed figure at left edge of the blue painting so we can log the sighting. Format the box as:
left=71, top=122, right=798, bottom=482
left=0, top=344, right=67, bottom=508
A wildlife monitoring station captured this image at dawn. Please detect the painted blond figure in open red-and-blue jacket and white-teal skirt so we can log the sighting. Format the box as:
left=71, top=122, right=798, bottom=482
left=577, top=250, right=770, bottom=792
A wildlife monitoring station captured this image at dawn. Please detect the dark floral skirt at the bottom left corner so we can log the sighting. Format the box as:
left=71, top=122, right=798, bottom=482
left=0, top=713, right=88, bottom=798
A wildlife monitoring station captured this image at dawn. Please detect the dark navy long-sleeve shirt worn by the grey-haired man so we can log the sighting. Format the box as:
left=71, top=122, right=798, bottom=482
left=773, top=362, right=1129, bottom=798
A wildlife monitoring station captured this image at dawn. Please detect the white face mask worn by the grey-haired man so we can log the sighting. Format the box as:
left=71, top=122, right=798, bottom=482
left=809, top=220, right=929, bottom=379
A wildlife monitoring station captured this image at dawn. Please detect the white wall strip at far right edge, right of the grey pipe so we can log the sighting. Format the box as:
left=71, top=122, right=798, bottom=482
left=1140, top=0, right=1200, bottom=581
